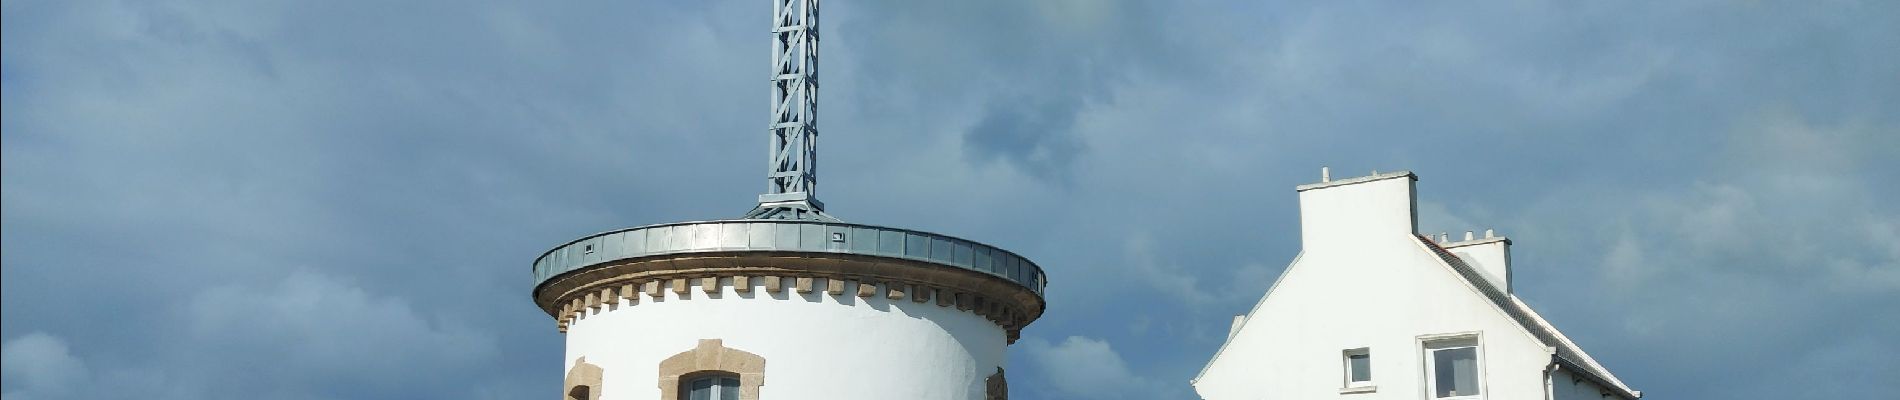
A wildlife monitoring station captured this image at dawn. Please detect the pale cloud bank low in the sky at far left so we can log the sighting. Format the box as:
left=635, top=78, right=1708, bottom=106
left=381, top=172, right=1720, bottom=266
left=0, top=271, right=519, bottom=400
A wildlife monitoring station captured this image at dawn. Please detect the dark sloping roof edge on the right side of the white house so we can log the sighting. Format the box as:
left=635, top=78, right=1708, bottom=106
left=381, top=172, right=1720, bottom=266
left=1414, top=235, right=1642, bottom=398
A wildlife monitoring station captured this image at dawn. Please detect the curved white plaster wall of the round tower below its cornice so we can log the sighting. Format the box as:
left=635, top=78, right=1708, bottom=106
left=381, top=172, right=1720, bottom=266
left=562, top=279, right=1007, bottom=400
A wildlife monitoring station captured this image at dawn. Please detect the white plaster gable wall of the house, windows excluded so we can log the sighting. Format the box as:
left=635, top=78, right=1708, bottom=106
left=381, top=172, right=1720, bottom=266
left=1195, top=178, right=1550, bottom=400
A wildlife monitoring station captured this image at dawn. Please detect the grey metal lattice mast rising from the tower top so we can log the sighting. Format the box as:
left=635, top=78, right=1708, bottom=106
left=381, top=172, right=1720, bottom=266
left=747, top=0, right=836, bottom=220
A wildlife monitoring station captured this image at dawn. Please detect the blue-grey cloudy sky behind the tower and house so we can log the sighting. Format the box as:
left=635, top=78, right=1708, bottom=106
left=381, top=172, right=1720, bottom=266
left=0, top=0, right=1900, bottom=400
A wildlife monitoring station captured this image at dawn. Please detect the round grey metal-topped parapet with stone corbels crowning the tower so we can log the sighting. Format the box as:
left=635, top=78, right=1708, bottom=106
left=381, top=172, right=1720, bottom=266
left=534, top=220, right=1049, bottom=341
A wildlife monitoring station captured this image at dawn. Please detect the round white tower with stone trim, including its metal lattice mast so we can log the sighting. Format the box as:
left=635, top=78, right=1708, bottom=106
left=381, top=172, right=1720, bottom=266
left=534, top=0, right=1047, bottom=400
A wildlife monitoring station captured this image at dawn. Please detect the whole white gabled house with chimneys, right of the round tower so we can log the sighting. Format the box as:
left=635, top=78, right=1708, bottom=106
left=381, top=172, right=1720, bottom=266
left=1191, top=173, right=1642, bottom=400
